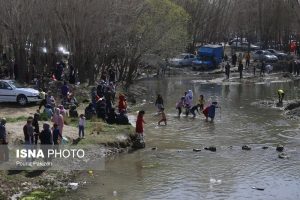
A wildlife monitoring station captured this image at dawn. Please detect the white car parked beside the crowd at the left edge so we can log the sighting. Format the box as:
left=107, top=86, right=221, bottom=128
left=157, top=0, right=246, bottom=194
left=0, top=80, right=42, bottom=106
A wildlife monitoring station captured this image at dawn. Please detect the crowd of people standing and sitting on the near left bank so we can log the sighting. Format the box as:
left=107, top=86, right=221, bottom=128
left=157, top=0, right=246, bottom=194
left=0, top=57, right=134, bottom=152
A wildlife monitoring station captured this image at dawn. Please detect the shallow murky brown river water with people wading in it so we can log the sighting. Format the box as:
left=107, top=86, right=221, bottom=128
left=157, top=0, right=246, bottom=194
left=70, top=76, right=300, bottom=200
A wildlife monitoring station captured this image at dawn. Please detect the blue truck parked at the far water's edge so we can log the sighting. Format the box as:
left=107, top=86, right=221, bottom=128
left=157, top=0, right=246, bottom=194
left=192, top=45, right=224, bottom=70
